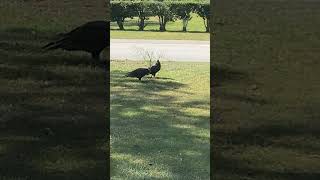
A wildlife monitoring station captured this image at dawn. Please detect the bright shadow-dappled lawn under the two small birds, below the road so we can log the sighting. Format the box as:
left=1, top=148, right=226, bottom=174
left=110, top=61, right=210, bottom=180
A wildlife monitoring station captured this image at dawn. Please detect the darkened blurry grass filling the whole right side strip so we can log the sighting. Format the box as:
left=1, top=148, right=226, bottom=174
left=211, top=0, right=320, bottom=180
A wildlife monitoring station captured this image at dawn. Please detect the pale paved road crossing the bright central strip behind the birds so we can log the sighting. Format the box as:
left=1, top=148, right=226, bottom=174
left=110, top=39, right=210, bottom=62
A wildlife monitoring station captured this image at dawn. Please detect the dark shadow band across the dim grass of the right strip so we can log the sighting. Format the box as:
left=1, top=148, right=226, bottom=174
left=214, top=119, right=320, bottom=153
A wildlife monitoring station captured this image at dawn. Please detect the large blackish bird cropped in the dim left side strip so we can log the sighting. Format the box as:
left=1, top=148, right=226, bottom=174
left=43, top=21, right=110, bottom=60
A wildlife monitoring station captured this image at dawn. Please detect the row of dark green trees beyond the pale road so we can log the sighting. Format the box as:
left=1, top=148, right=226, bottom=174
left=111, top=0, right=210, bottom=32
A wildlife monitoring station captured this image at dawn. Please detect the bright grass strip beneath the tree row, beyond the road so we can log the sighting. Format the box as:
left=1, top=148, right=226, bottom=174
left=111, top=14, right=210, bottom=41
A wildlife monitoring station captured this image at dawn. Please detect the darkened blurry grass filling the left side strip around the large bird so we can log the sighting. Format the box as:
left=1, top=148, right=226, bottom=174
left=0, top=0, right=108, bottom=180
